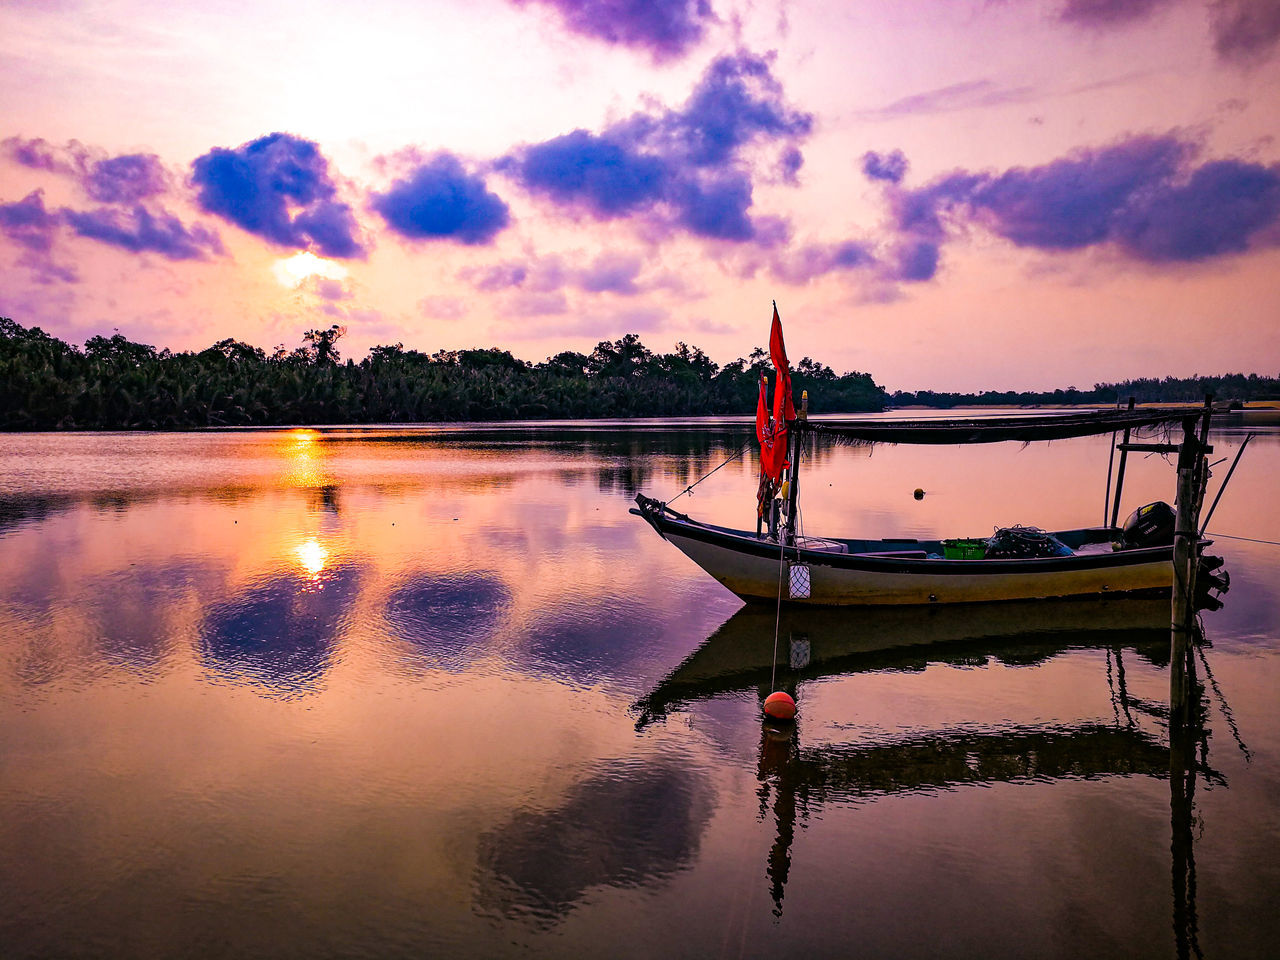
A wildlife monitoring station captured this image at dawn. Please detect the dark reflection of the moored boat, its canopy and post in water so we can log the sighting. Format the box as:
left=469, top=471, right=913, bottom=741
left=634, top=598, right=1228, bottom=957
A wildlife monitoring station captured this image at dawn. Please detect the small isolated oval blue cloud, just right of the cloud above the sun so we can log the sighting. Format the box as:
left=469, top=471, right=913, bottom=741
left=371, top=154, right=511, bottom=246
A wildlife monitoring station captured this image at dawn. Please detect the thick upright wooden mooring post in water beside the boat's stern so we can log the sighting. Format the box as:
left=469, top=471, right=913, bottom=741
left=1169, top=417, right=1203, bottom=726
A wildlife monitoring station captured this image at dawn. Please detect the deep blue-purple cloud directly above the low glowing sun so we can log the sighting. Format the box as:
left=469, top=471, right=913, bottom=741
left=191, top=133, right=364, bottom=257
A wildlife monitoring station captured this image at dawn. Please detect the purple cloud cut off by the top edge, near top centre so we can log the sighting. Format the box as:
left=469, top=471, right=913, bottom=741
left=513, top=0, right=716, bottom=63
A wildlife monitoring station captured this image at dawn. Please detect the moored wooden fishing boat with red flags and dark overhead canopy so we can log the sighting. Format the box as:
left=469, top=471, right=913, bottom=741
left=631, top=306, right=1234, bottom=605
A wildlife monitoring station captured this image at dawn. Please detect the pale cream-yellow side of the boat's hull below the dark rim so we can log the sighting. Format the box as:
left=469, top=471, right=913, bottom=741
left=666, top=530, right=1172, bottom=605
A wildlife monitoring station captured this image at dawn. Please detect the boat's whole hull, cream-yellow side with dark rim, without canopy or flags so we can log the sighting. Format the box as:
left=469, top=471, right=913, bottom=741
left=641, top=513, right=1172, bottom=607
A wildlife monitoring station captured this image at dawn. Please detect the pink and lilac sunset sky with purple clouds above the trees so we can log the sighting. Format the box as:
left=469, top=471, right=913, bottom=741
left=0, top=0, right=1280, bottom=390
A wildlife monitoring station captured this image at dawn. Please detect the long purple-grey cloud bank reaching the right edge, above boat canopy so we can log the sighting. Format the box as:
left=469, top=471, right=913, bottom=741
left=891, top=134, right=1280, bottom=273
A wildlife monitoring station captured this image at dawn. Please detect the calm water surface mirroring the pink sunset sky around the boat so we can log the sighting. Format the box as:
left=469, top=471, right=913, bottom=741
left=0, top=422, right=1280, bottom=960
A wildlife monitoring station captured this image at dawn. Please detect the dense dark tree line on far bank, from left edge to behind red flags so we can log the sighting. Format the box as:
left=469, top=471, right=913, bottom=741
left=0, top=317, right=888, bottom=430
